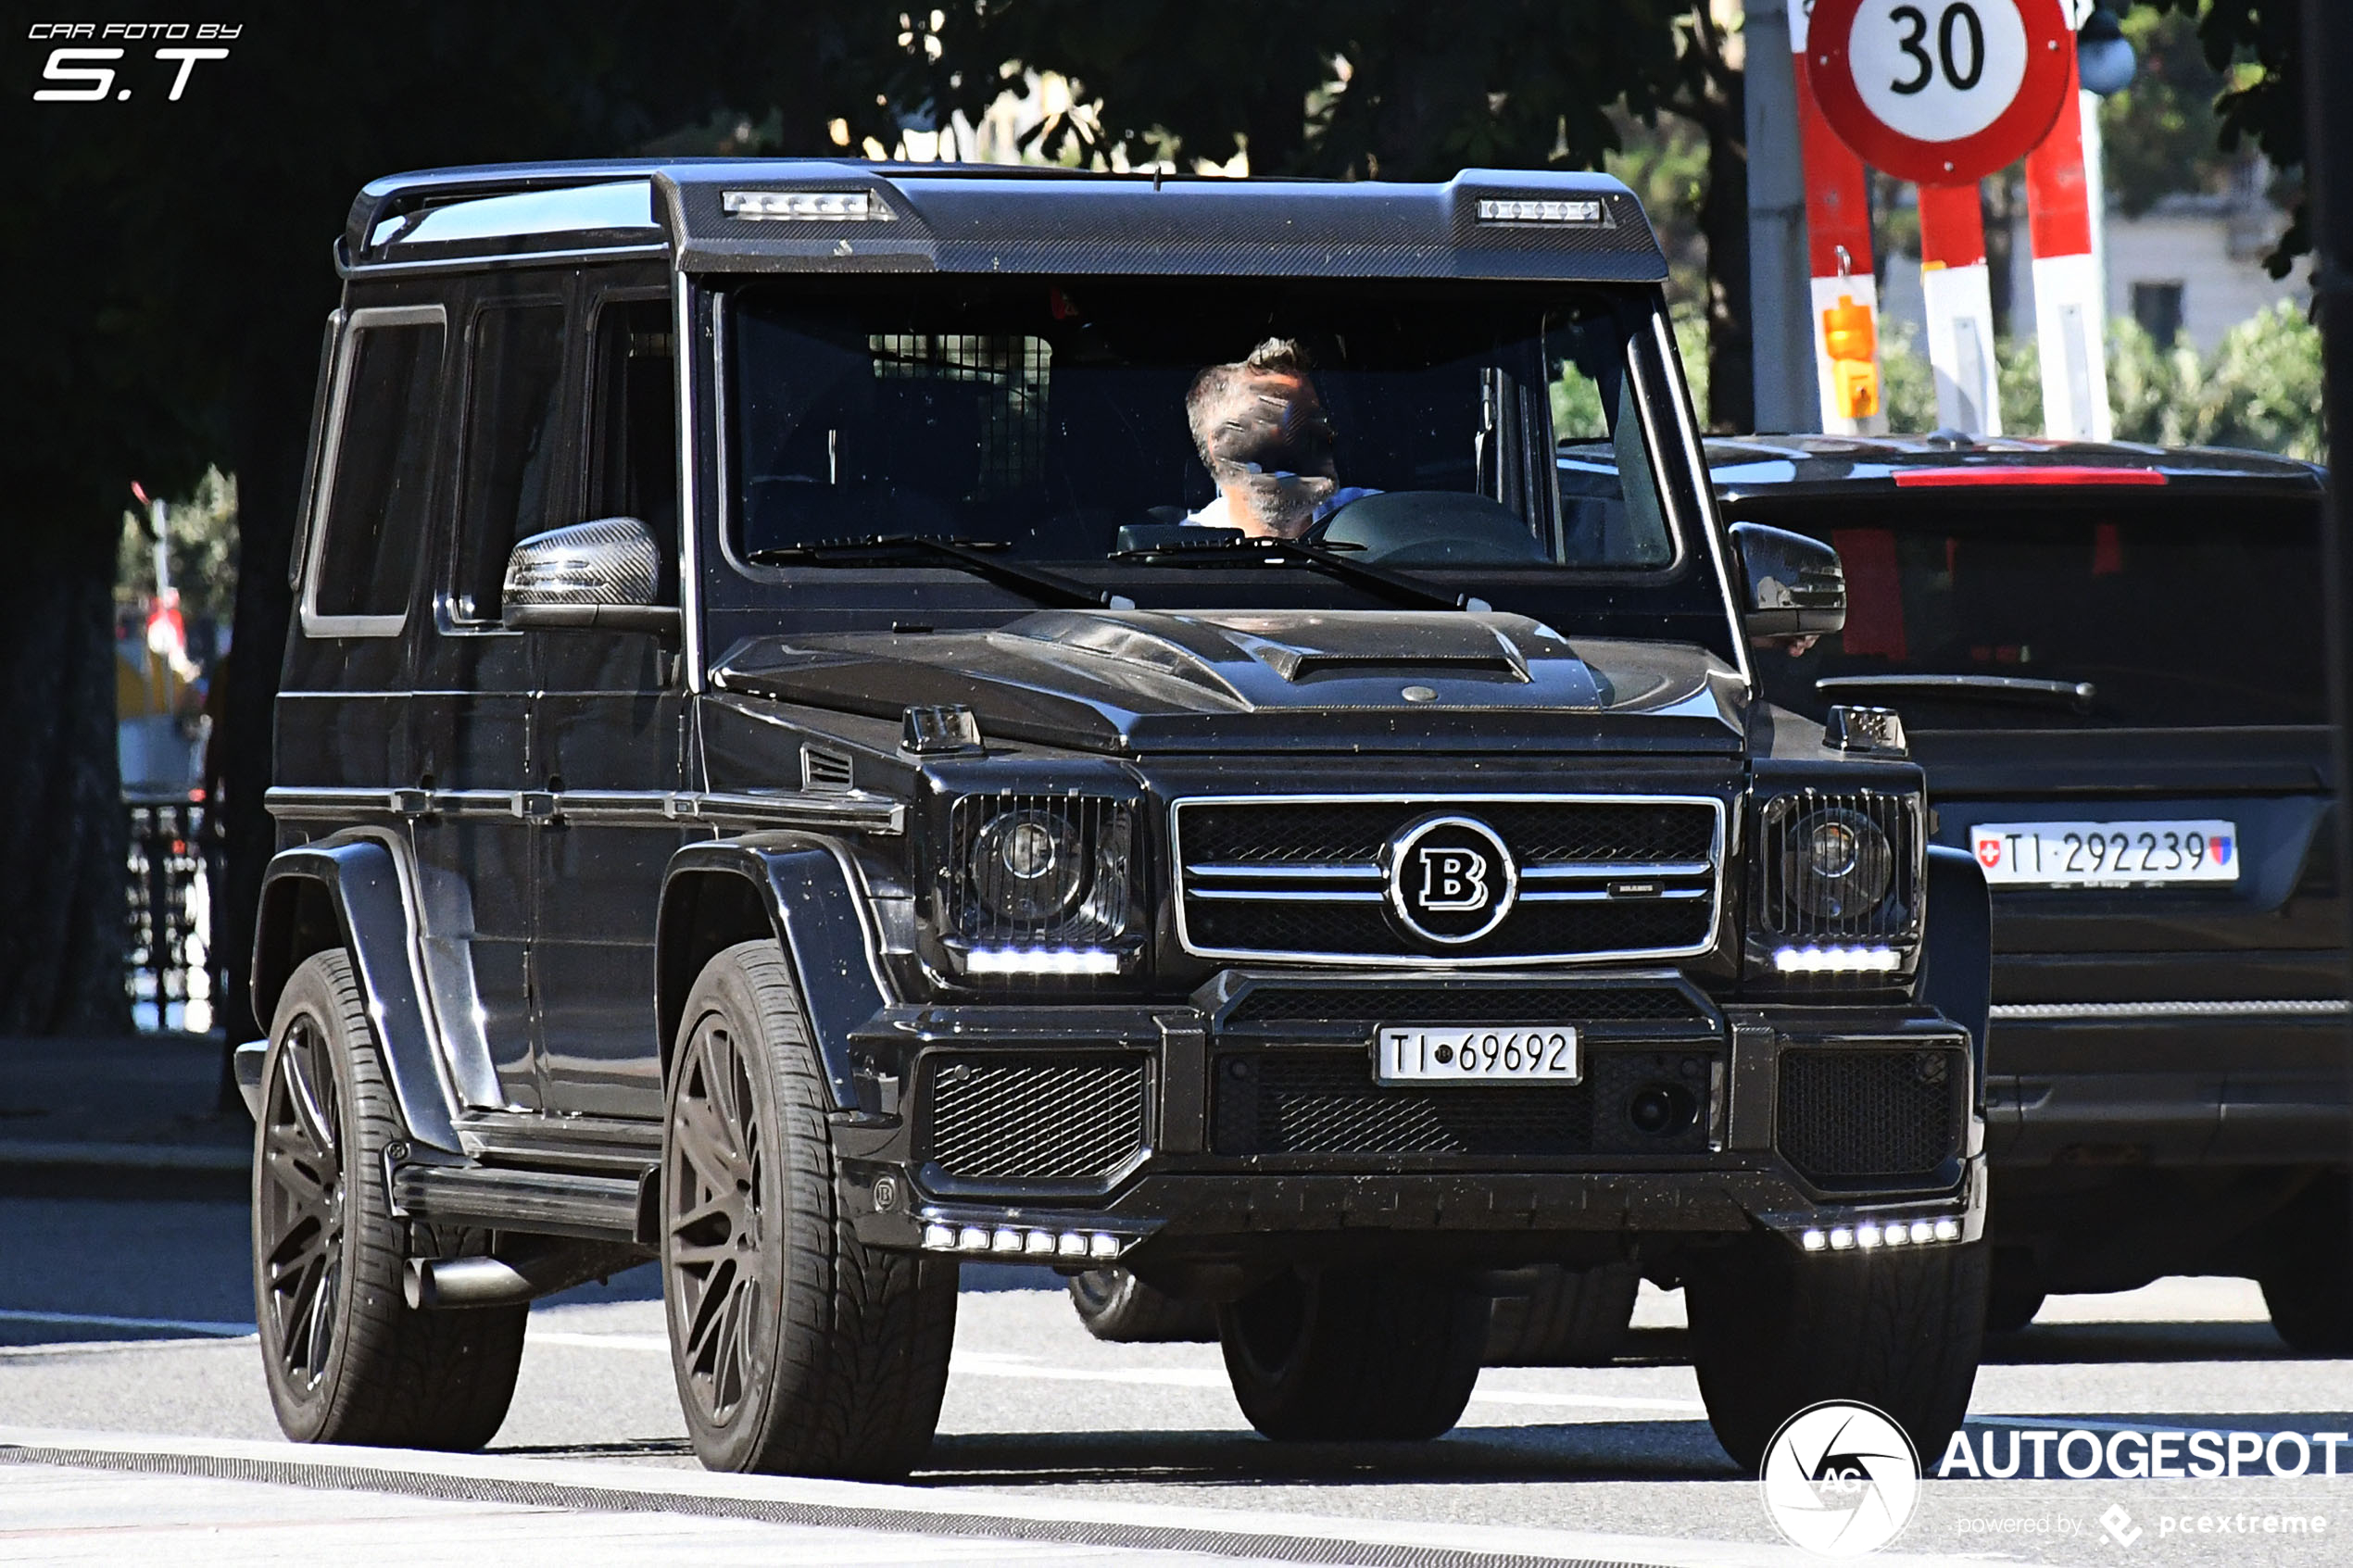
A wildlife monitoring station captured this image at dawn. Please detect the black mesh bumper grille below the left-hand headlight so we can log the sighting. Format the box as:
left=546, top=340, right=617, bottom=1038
left=923, top=1053, right=1146, bottom=1183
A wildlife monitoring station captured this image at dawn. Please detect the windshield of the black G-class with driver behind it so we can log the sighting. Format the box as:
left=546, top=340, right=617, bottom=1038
left=724, top=278, right=1685, bottom=583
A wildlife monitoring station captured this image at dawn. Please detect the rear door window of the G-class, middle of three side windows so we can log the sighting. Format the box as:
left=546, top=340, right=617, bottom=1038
left=449, top=301, right=565, bottom=625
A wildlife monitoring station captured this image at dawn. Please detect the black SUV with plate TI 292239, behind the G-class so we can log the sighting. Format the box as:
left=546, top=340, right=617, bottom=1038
left=1591, top=435, right=2353, bottom=1354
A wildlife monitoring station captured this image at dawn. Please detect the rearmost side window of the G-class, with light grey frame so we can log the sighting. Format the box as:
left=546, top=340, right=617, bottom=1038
left=304, top=306, right=445, bottom=637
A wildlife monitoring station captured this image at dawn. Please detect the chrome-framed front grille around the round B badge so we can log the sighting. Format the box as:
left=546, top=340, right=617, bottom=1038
left=1169, top=795, right=1725, bottom=966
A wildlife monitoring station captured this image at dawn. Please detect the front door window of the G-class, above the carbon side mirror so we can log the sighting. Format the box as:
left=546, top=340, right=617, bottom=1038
left=585, top=298, right=678, bottom=583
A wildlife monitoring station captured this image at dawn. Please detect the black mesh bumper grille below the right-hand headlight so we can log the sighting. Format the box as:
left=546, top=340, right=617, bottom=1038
left=1781, top=1047, right=1969, bottom=1187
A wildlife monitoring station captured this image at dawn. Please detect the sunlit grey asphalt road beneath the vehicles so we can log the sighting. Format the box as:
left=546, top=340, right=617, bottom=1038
left=0, top=1198, right=2353, bottom=1568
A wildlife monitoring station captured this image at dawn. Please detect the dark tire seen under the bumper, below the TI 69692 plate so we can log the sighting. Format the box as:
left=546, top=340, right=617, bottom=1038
left=1216, top=1267, right=1487, bottom=1443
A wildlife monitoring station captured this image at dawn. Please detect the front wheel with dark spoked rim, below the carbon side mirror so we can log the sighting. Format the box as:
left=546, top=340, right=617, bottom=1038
left=661, top=940, right=955, bottom=1479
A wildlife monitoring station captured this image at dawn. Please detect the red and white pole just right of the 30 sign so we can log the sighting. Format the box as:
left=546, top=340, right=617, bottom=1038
left=2026, top=38, right=2115, bottom=442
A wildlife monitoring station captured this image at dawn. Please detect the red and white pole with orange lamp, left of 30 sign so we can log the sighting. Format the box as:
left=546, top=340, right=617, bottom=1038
left=1788, top=31, right=1887, bottom=435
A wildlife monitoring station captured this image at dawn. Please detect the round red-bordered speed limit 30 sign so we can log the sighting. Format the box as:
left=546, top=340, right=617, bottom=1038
left=1805, top=0, right=2075, bottom=186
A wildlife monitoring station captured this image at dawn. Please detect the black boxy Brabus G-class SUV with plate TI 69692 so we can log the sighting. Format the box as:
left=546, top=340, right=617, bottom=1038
left=240, top=162, right=1986, bottom=1476
